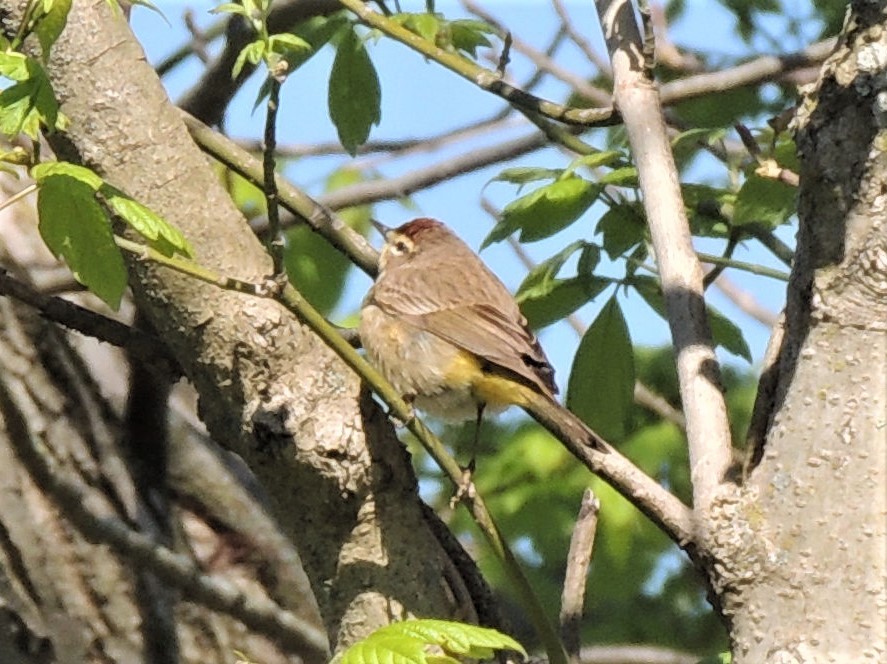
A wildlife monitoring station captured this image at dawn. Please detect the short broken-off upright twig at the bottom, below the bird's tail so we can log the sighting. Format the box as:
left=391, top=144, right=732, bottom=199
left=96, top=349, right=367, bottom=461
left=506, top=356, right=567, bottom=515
left=560, top=489, right=601, bottom=664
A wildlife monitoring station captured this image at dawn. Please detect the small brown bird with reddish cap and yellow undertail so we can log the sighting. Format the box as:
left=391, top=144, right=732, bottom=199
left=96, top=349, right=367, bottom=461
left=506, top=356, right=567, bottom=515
left=360, top=218, right=602, bottom=454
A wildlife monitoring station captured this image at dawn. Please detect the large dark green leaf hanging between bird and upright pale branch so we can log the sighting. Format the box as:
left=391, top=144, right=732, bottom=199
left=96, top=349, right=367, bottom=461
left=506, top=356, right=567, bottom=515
left=567, top=296, right=635, bottom=440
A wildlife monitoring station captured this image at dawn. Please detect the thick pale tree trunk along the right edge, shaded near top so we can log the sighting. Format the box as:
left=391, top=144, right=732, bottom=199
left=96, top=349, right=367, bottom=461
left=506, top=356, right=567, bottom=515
left=711, top=2, right=887, bottom=664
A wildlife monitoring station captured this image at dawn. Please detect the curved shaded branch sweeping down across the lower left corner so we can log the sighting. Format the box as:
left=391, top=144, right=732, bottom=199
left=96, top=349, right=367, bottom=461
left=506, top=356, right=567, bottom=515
left=0, top=366, right=329, bottom=664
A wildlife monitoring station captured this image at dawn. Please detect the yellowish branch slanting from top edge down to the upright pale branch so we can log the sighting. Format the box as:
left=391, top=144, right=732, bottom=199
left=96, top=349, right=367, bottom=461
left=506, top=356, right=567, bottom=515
left=339, top=0, right=619, bottom=127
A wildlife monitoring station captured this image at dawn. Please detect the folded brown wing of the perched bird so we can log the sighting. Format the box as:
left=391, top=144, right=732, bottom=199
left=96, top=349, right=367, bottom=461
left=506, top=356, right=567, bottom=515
left=372, top=278, right=557, bottom=397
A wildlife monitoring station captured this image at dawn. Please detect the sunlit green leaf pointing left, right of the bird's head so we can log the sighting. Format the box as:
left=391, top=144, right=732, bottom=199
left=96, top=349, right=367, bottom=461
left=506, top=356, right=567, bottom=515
left=481, top=176, right=602, bottom=248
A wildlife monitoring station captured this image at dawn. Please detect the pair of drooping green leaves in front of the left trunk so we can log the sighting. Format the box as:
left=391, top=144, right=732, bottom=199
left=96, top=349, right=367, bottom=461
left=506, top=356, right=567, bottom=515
left=31, top=162, right=192, bottom=309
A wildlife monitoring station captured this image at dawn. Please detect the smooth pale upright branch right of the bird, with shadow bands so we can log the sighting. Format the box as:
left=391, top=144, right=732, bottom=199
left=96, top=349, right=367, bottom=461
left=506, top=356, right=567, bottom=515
left=596, top=0, right=732, bottom=514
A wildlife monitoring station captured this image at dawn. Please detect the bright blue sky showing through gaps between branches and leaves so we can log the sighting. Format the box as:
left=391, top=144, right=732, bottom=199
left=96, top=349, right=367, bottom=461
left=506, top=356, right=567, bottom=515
left=132, top=0, right=824, bottom=392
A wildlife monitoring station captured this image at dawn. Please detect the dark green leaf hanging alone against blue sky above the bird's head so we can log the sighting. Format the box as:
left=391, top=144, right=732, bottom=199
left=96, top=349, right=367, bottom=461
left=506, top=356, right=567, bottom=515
left=328, top=30, right=382, bottom=155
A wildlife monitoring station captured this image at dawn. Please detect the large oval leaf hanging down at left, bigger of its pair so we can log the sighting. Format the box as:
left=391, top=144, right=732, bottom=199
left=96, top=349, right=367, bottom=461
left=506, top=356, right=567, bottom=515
left=37, top=175, right=126, bottom=310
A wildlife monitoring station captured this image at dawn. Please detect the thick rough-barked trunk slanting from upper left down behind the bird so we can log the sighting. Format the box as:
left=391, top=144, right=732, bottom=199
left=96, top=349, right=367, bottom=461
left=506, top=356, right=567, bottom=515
left=0, top=0, right=486, bottom=661
